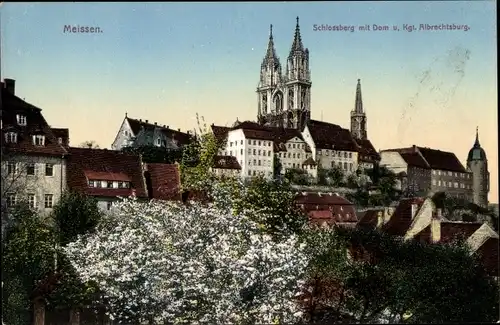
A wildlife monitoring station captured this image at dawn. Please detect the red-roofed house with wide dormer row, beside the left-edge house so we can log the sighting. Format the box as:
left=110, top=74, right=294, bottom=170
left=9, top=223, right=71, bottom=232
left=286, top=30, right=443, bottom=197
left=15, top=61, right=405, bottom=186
left=67, top=147, right=149, bottom=210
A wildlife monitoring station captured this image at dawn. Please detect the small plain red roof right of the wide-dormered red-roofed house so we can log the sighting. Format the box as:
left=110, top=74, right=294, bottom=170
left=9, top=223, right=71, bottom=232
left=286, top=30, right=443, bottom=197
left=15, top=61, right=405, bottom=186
left=145, top=164, right=181, bottom=201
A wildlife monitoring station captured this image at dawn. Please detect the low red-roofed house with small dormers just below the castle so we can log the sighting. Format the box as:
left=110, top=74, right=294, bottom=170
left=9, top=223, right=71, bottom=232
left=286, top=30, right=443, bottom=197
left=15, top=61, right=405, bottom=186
left=295, top=192, right=358, bottom=227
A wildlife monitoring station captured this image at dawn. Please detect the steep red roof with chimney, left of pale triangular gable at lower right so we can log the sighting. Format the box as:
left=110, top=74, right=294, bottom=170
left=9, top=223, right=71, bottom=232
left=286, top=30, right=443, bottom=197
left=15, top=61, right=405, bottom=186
left=382, top=197, right=425, bottom=236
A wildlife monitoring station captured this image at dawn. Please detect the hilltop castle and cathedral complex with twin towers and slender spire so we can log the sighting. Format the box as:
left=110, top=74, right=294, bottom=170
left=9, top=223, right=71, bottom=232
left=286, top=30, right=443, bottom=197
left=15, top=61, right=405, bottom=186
left=212, top=17, right=380, bottom=178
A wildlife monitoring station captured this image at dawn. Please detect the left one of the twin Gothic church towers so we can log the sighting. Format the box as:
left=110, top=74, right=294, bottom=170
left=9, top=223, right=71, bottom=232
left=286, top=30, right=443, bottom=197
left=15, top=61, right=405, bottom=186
left=257, top=25, right=284, bottom=126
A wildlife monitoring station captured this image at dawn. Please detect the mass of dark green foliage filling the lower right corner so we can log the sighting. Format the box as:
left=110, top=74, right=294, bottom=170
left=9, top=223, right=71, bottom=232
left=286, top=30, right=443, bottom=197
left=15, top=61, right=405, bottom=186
left=302, top=229, right=498, bottom=323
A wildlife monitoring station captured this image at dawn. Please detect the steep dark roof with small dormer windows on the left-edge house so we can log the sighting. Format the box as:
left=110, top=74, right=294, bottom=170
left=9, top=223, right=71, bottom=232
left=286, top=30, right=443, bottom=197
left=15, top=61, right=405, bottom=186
left=1, top=83, right=67, bottom=156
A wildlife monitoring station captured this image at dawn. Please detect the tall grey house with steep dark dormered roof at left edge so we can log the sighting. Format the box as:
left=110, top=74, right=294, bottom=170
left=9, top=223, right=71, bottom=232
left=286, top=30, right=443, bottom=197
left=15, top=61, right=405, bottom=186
left=1, top=79, right=69, bottom=214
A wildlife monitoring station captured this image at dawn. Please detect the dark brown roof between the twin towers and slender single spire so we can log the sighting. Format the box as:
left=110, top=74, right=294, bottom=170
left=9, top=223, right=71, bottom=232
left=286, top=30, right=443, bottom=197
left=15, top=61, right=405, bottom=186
left=307, top=120, right=358, bottom=152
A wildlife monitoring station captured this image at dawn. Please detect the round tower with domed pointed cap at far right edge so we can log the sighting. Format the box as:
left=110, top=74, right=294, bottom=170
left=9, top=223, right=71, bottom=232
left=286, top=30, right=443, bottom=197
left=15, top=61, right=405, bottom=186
left=467, top=128, right=490, bottom=208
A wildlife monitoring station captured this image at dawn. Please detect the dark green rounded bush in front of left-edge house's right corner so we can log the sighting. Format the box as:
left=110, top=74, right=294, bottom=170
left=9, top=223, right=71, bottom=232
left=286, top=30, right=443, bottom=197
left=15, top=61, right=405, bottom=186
left=51, top=192, right=101, bottom=245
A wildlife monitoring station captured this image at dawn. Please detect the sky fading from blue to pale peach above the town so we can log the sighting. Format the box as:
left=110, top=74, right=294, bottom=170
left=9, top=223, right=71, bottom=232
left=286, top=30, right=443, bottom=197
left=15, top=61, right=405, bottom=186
left=0, top=1, right=498, bottom=202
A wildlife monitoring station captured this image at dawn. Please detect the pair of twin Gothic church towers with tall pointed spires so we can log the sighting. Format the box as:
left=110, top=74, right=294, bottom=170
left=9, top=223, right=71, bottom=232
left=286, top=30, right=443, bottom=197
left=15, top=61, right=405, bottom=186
left=257, top=17, right=311, bottom=129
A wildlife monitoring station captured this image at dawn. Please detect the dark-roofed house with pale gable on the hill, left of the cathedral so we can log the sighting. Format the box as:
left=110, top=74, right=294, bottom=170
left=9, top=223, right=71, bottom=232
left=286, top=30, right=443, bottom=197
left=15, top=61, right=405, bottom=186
left=111, top=114, right=193, bottom=150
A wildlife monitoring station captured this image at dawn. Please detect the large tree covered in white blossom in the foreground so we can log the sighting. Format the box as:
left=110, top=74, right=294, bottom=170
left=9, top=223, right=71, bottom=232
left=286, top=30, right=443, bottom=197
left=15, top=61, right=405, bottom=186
left=65, top=196, right=307, bottom=324
